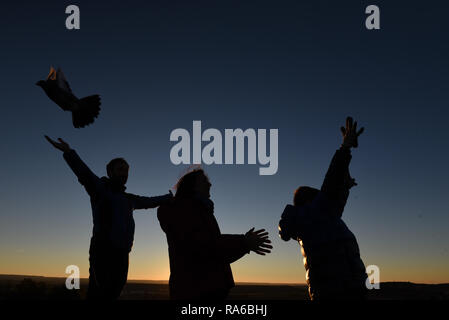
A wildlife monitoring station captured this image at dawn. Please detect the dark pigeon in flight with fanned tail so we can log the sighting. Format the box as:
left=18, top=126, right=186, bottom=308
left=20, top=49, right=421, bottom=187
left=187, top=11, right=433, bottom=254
left=36, top=67, right=101, bottom=128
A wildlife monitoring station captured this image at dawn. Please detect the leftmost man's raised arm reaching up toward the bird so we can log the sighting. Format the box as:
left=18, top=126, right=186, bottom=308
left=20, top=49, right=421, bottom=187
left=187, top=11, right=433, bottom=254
left=45, top=136, right=104, bottom=196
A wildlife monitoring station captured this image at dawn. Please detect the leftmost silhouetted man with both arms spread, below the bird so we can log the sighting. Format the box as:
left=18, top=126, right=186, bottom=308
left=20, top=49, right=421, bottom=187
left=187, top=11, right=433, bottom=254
left=45, top=136, right=173, bottom=299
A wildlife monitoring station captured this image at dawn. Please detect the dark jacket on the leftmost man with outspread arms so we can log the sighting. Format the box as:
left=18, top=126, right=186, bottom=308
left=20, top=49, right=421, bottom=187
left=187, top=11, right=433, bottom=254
left=63, top=150, right=172, bottom=252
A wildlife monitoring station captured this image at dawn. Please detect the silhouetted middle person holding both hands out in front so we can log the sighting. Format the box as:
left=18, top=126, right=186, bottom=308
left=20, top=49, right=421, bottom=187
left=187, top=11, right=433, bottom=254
left=157, top=169, right=272, bottom=300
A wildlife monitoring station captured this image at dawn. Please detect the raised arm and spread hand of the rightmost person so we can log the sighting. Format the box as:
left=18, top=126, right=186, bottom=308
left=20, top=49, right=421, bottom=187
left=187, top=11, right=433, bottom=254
left=321, top=117, right=364, bottom=217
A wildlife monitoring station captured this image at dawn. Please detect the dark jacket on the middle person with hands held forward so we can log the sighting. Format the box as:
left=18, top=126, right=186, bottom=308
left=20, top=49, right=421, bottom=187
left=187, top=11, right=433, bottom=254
left=157, top=197, right=249, bottom=299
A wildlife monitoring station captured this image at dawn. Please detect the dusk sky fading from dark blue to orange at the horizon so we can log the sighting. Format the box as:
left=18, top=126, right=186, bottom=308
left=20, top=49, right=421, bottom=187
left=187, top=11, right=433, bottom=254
left=0, top=0, right=449, bottom=283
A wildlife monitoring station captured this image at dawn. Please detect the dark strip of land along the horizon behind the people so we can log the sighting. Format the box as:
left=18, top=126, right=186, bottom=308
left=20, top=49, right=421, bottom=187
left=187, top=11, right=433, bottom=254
left=0, top=275, right=449, bottom=300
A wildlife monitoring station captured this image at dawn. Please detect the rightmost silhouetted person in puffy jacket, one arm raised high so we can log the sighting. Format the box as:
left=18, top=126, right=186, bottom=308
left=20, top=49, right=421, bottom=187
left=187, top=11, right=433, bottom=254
left=279, top=117, right=367, bottom=300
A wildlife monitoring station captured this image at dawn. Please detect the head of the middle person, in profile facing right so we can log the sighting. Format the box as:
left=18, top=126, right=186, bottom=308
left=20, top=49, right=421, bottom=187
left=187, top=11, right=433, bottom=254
left=176, top=169, right=212, bottom=198
